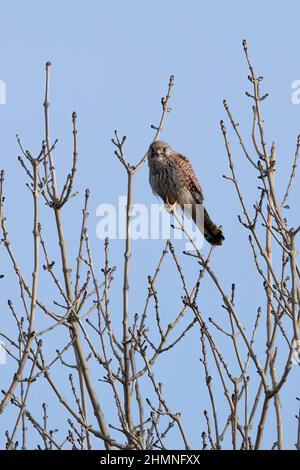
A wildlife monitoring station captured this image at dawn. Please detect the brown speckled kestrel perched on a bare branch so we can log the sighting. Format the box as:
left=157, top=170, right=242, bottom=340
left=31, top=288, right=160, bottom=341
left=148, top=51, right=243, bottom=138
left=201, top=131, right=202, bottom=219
left=148, top=141, right=225, bottom=245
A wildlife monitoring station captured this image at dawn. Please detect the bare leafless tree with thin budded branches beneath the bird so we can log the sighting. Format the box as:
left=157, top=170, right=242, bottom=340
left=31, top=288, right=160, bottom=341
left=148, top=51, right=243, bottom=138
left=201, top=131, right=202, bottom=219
left=0, top=41, right=300, bottom=450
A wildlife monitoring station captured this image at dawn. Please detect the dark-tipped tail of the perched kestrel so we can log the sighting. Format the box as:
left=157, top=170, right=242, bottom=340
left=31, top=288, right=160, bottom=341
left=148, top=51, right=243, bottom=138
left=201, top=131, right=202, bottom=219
left=191, top=204, right=225, bottom=245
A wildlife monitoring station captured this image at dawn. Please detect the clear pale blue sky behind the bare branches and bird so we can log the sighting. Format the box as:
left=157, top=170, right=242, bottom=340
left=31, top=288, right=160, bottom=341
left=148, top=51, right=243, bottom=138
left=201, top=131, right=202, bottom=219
left=0, top=0, right=300, bottom=447
